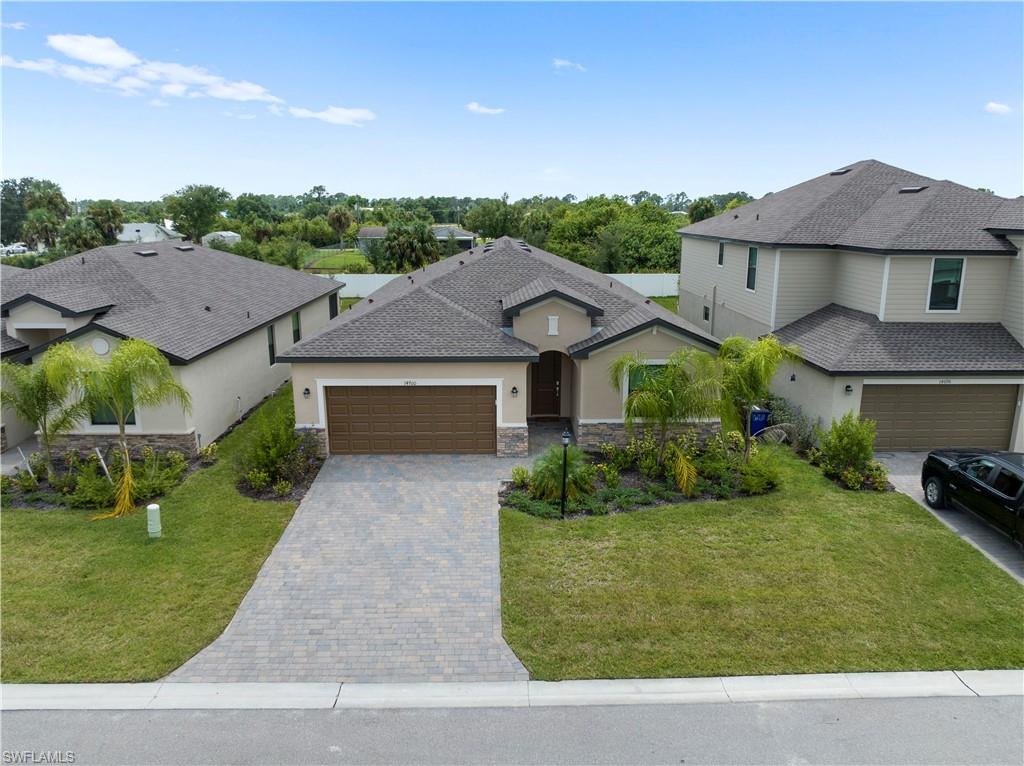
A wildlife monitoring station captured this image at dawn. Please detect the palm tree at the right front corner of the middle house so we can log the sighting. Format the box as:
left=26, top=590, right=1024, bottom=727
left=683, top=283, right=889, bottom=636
left=718, top=335, right=800, bottom=460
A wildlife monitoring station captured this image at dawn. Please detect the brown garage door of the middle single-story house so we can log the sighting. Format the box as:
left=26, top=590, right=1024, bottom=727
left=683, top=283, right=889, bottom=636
left=325, top=386, right=497, bottom=455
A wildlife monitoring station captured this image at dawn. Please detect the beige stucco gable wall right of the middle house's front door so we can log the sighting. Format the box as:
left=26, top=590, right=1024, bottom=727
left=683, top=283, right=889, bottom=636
left=577, top=328, right=714, bottom=422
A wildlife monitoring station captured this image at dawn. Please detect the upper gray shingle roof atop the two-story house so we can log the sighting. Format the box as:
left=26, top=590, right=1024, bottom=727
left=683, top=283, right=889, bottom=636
left=679, top=160, right=1024, bottom=255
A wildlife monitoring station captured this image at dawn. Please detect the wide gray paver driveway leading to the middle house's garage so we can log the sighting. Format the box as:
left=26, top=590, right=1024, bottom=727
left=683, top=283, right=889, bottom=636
left=168, top=455, right=527, bottom=682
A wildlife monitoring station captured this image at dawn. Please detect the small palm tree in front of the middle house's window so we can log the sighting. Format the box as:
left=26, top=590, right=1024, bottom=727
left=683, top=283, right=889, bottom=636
left=609, top=348, right=721, bottom=462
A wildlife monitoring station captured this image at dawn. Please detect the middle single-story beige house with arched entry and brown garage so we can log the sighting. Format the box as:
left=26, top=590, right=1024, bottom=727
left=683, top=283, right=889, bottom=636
left=280, top=238, right=718, bottom=456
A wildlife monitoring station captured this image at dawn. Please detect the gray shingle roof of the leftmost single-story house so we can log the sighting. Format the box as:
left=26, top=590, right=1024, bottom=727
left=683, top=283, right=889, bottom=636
left=0, top=242, right=338, bottom=361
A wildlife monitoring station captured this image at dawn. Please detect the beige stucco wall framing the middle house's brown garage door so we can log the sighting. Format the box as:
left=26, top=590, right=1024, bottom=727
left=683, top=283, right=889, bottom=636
left=292, top=361, right=529, bottom=428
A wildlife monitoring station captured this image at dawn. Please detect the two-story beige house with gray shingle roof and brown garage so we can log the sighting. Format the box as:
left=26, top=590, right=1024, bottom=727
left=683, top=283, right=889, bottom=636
left=679, top=160, right=1024, bottom=450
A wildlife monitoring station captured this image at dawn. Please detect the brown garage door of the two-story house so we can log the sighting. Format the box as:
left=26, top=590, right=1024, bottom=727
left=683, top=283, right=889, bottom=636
left=860, top=384, right=1017, bottom=450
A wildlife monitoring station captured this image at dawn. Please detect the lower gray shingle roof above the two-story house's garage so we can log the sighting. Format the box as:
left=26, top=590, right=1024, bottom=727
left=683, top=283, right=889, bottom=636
left=775, top=303, right=1024, bottom=375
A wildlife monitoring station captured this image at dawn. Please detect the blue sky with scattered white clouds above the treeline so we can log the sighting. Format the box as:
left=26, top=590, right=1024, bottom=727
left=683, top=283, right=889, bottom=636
left=0, top=2, right=1024, bottom=199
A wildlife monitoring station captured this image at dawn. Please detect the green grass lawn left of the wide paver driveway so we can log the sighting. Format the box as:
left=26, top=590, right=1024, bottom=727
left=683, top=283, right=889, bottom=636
left=0, top=388, right=295, bottom=682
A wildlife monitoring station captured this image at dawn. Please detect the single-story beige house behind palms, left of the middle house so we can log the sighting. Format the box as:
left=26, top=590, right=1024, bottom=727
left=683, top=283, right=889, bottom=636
left=0, top=242, right=338, bottom=453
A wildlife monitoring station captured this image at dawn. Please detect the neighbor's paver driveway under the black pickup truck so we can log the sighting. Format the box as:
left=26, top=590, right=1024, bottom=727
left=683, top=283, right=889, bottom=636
left=874, top=453, right=1024, bottom=583
